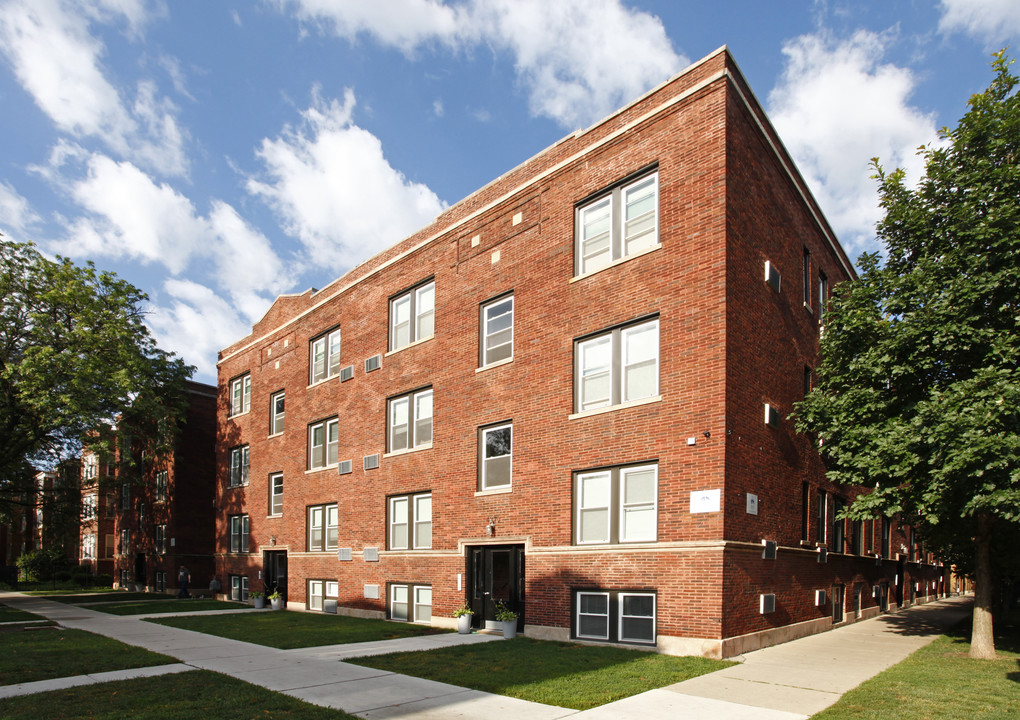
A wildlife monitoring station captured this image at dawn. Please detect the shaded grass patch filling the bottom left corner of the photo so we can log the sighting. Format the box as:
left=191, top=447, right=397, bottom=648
left=0, top=670, right=358, bottom=720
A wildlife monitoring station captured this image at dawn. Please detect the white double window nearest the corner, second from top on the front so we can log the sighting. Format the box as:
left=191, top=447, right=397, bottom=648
left=574, top=317, right=662, bottom=412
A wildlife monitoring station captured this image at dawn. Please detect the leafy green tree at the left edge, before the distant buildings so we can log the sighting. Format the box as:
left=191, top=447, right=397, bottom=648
left=0, top=237, right=193, bottom=516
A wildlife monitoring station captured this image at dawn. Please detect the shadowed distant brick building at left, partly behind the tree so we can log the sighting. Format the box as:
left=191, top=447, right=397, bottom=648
left=80, top=382, right=216, bottom=593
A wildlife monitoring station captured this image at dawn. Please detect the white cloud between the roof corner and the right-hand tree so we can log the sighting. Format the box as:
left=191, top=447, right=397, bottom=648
left=768, top=31, right=936, bottom=257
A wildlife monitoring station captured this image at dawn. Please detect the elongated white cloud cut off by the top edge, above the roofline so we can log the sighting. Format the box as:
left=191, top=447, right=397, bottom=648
left=277, top=0, right=689, bottom=130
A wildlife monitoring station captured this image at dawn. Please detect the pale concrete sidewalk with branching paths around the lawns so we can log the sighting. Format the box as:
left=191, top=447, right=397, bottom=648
left=0, top=593, right=971, bottom=720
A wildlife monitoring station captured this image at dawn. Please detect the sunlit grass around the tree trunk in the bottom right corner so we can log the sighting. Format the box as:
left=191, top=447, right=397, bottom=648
left=812, top=614, right=1020, bottom=720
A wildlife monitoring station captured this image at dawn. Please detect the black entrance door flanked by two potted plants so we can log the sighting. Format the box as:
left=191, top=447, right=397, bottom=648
left=468, top=545, right=524, bottom=630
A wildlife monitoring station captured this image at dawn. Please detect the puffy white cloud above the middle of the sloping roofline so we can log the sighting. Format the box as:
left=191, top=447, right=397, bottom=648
left=248, top=90, right=444, bottom=271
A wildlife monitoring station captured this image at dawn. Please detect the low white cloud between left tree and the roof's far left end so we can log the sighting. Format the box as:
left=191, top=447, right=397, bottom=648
left=147, top=279, right=251, bottom=382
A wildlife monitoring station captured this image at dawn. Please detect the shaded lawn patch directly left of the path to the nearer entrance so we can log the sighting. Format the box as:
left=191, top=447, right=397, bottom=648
left=148, top=601, right=446, bottom=650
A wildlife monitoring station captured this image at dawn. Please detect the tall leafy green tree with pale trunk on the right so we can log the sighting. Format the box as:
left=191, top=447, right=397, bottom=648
left=797, top=53, right=1020, bottom=658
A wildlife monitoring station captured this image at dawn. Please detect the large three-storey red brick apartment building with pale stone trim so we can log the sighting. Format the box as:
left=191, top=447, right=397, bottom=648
left=216, top=49, right=945, bottom=657
